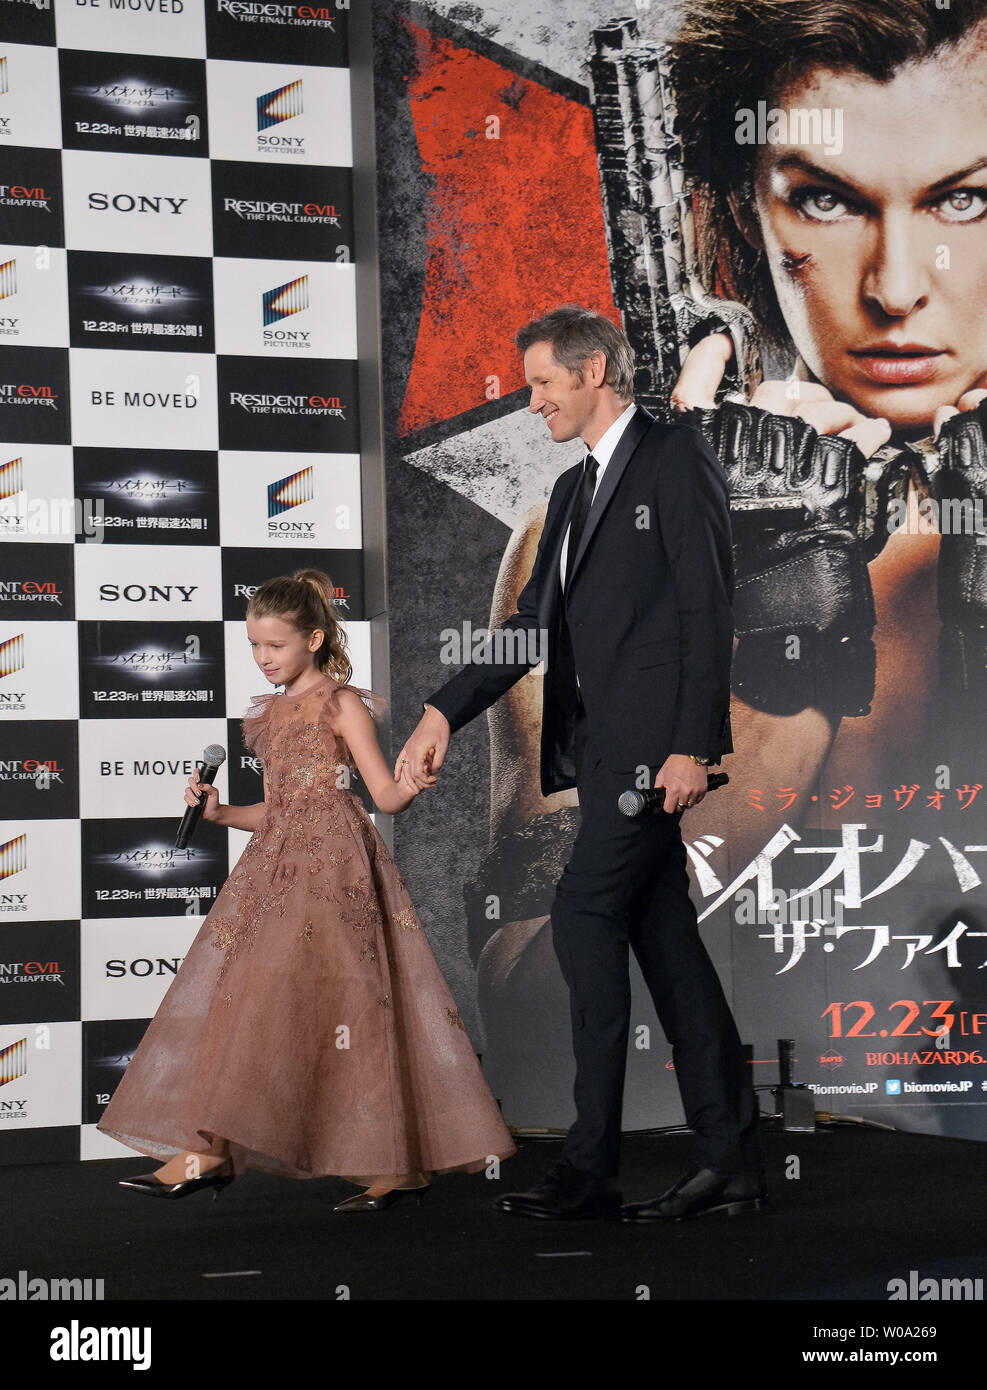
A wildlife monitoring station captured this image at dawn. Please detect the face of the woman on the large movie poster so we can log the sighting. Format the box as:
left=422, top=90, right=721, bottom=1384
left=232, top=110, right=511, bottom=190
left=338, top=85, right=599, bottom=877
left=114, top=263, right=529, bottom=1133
left=747, top=40, right=987, bottom=428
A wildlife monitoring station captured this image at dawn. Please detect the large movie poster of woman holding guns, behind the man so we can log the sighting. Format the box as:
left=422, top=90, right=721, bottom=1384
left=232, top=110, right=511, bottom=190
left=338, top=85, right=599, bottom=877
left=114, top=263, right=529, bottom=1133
left=375, top=0, right=987, bottom=1138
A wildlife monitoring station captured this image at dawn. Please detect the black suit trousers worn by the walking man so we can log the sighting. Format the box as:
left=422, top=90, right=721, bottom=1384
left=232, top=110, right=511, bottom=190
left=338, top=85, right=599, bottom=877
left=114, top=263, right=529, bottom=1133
left=552, top=714, right=762, bottom=1179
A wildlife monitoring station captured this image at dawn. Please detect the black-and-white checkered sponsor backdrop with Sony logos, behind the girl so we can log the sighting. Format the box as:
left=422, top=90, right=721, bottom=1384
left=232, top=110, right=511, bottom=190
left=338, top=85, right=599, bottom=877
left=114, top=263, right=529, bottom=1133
left=0, top=0, right=371, bottom=1162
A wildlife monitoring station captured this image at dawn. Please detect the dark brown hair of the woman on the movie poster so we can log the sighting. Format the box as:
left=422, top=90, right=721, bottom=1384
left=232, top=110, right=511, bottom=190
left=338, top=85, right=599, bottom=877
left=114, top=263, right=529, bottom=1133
left=670, top=0, right=987, bottom=342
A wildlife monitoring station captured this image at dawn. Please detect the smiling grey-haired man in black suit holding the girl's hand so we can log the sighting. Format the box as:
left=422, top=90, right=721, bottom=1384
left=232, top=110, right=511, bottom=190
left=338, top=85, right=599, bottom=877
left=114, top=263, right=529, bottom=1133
left=395, top=306, right=763, bottom=1222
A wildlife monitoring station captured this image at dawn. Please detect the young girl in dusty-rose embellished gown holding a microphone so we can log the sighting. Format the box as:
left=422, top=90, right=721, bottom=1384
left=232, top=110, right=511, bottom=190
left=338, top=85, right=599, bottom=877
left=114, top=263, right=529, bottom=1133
left=97, top=570, right=514, bottom=1211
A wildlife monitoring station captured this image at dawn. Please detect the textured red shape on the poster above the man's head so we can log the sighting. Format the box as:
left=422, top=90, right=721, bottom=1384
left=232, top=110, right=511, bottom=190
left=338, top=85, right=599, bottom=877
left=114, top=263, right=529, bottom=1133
left=399, top=22, right=620, bottom=435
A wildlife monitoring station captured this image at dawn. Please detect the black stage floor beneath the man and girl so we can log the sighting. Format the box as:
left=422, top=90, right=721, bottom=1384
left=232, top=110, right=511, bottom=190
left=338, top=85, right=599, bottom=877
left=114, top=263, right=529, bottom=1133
left=0, top=1129, right=987, bottom=1311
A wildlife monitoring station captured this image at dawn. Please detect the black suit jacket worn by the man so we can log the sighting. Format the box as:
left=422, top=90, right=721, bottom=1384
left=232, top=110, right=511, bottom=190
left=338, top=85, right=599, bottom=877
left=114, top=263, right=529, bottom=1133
left=427, top=407, right=734, bottom=796
